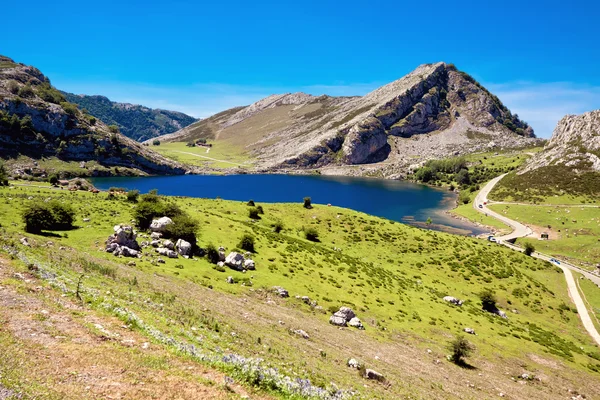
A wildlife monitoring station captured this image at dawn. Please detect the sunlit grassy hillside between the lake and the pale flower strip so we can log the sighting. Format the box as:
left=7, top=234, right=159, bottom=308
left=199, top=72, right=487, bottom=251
left=0, top=188, right=600, bottom=398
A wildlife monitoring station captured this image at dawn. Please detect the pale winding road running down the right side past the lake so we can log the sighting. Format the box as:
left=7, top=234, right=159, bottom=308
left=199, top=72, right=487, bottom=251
left=473, top=174, right=600, bottom=346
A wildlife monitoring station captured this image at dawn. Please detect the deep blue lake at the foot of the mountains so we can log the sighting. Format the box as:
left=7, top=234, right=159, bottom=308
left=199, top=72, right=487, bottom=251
left=92, top=174, right=487, bottom=235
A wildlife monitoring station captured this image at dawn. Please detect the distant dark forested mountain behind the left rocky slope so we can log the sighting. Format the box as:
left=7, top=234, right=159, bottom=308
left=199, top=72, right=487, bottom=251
left=62, top=92, right=196, bottom=142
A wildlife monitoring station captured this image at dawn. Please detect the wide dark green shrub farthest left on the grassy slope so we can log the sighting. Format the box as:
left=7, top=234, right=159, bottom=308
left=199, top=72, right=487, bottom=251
left=22, top=201, right=75, bottom=233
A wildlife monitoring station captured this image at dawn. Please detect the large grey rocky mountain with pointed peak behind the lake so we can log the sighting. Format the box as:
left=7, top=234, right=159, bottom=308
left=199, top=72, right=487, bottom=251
left=151, top=62, right=536, bottom=177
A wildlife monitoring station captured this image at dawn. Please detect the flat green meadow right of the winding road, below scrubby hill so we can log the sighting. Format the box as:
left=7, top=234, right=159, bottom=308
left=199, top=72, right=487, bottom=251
left=490, top=204, right=600, bottom=267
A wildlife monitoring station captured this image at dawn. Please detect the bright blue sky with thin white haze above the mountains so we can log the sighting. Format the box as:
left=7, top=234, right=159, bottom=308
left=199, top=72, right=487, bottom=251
left=0, top=0, right=600, bottom=137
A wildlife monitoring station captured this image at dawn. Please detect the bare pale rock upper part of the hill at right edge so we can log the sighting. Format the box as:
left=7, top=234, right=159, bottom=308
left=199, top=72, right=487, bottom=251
left=521, top=110, right=600, bottom=173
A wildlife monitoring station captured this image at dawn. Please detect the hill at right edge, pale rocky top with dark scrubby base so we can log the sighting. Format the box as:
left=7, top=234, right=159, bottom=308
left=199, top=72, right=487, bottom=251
left=494, top=110, right=600, bottom=201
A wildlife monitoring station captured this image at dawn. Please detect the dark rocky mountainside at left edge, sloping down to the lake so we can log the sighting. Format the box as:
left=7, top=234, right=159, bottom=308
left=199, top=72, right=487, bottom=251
left=0, top=56, right=185, bottom=174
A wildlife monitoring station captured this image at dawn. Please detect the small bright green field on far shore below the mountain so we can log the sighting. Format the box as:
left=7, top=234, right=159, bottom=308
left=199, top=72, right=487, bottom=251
left=152, top=141, right=252, bottom=169
